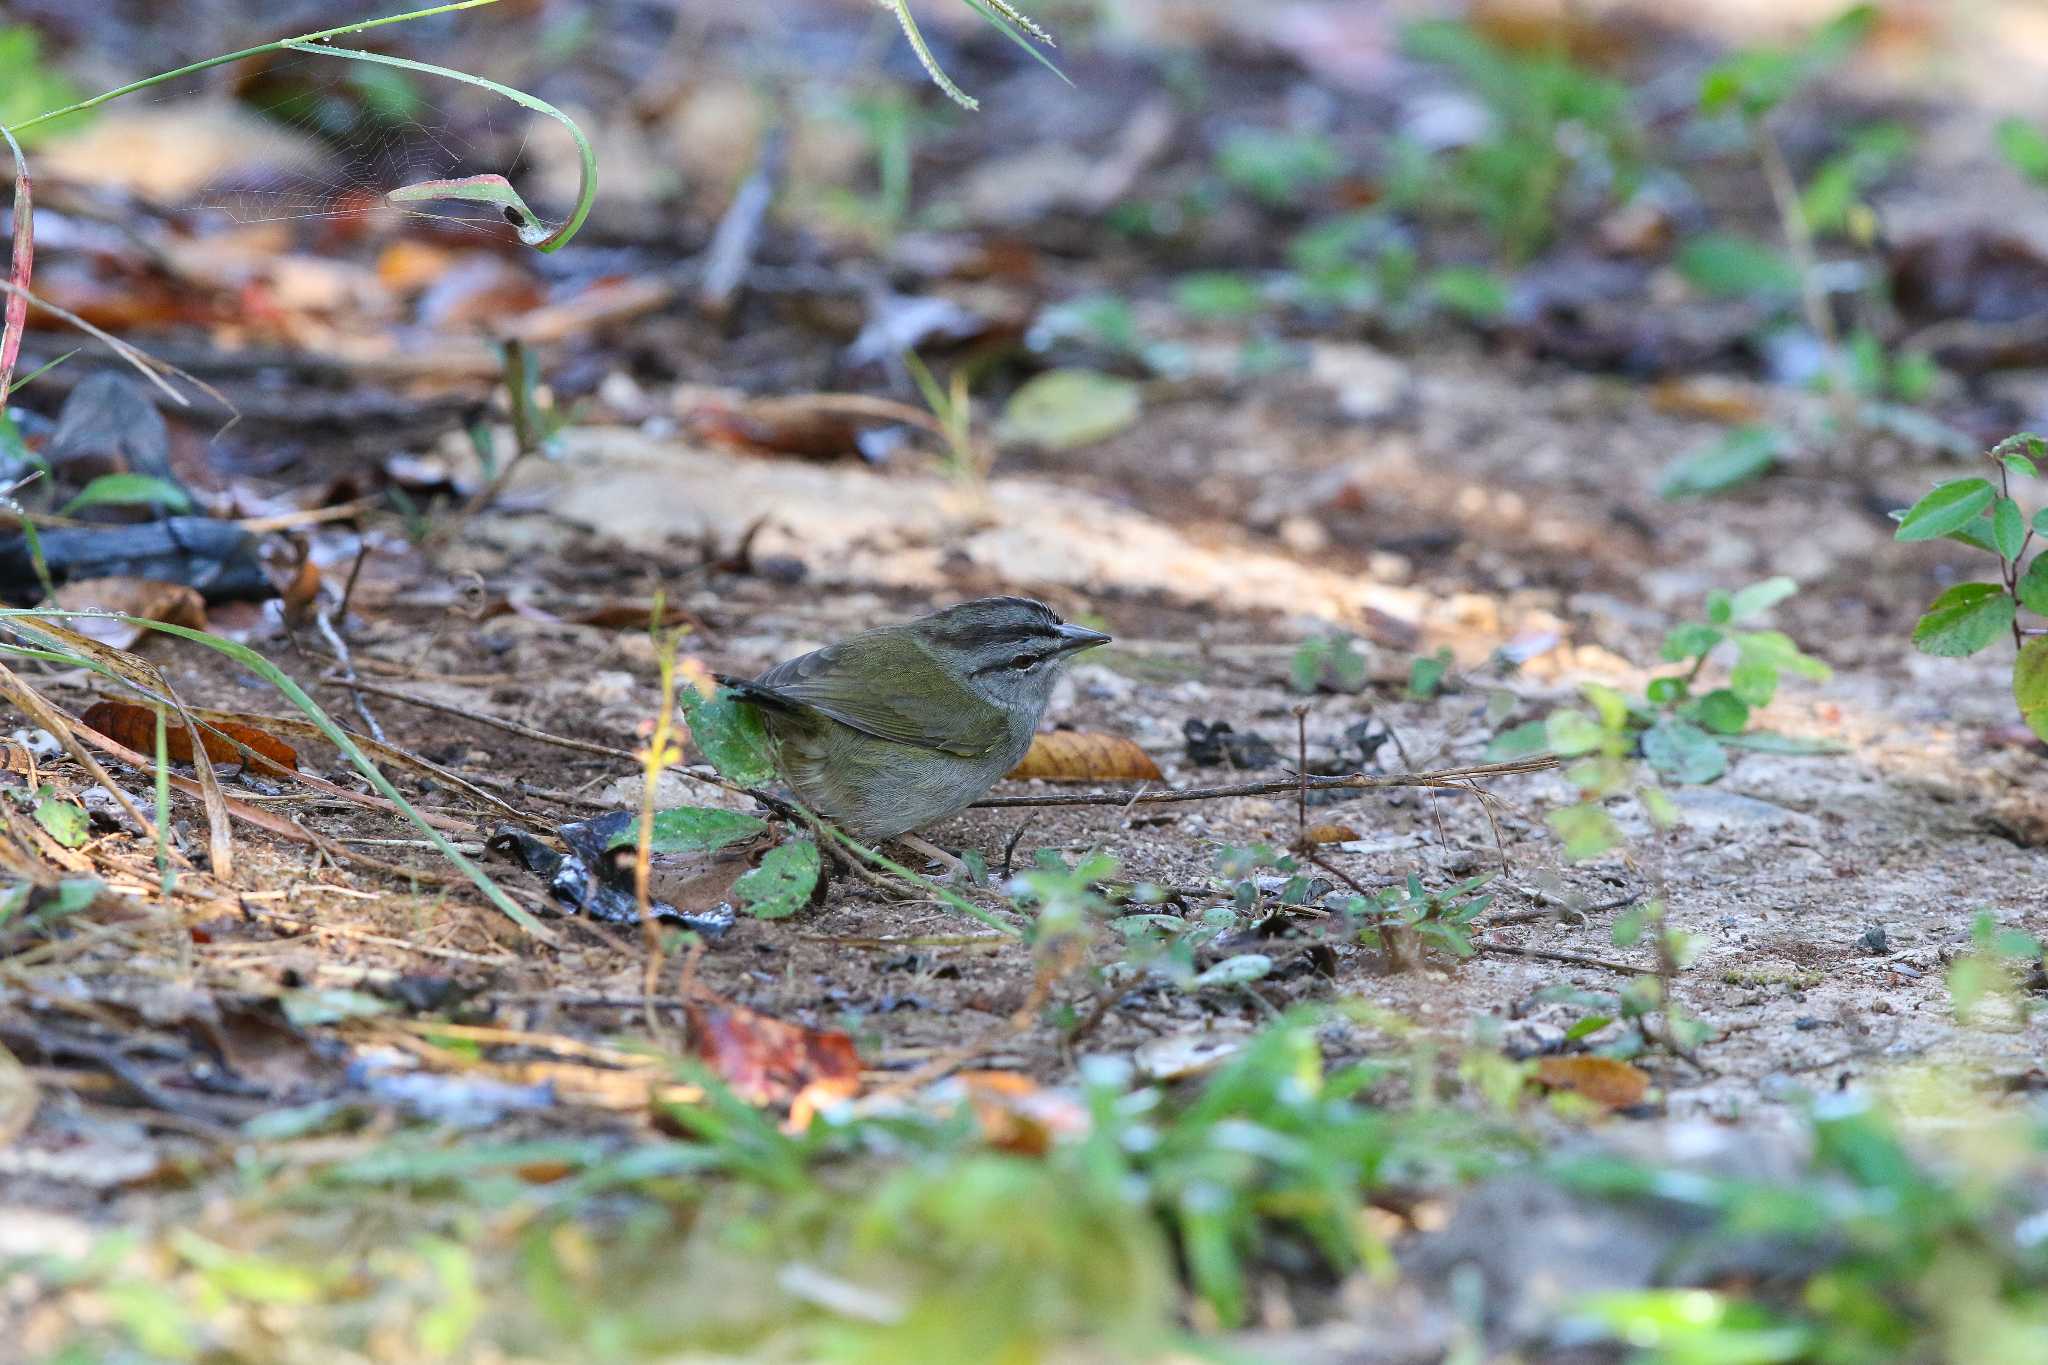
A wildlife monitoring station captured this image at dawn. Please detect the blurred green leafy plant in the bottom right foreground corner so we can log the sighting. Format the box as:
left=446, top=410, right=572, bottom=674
left=1554, top=1093, right=2048, bottom=1365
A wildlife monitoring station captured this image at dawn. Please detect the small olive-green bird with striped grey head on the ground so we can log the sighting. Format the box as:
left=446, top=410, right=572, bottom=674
left=719, top=598, right=1110, bottom=841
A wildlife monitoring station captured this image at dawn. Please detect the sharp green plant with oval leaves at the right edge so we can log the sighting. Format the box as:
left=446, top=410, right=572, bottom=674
left=1892, top=432, right=2048, bottom=739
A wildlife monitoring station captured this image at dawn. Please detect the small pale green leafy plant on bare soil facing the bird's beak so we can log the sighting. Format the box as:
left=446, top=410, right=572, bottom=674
left=1487, top=577, right=1831, bottom=860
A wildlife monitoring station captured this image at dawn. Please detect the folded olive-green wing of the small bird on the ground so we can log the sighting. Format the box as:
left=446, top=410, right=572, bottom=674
left=739, top=636, right=1010, bottom=757
